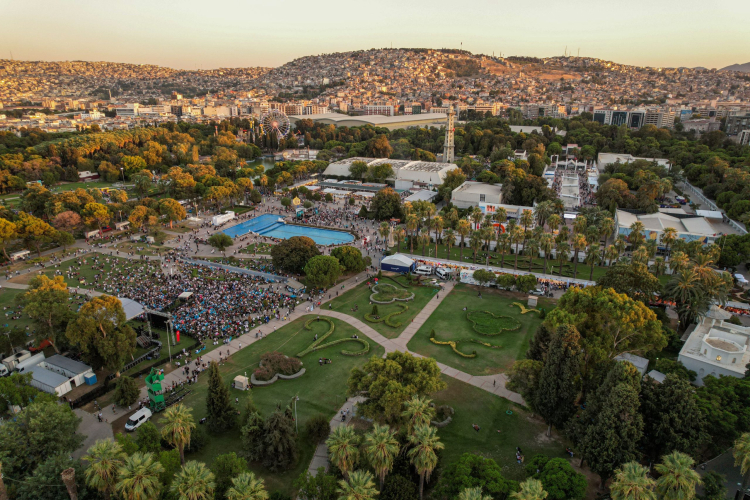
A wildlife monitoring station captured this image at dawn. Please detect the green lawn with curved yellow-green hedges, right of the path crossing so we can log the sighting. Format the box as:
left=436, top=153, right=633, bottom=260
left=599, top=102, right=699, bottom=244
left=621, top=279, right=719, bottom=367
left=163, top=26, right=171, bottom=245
left=408, top=284, right=554, bottom=375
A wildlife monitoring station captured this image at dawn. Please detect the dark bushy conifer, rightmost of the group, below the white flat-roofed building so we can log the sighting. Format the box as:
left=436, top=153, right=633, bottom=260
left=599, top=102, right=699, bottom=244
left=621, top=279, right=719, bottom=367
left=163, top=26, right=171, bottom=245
left=641, top=373, right=707, bottom=461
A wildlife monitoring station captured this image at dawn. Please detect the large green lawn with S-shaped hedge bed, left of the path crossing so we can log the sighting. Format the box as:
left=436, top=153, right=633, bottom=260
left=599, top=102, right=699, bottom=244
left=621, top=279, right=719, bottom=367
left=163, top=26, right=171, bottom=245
left=171, top=315, right=384, bottom=494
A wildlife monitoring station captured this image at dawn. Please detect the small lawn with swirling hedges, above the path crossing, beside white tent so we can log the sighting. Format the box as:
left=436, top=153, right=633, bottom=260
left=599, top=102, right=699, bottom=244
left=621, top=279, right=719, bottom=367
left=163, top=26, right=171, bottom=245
left=330, top=278, right=437, bottom=339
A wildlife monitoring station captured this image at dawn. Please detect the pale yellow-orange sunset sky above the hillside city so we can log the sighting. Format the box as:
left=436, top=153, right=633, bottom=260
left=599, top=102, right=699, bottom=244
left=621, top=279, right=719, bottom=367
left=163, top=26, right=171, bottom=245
left=0, top=0, right=750, bottom=69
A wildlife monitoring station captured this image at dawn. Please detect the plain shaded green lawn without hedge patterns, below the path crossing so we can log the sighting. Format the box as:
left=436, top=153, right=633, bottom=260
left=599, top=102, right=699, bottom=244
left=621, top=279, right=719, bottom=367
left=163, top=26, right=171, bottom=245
left=431, top=376, right=567, bottom=481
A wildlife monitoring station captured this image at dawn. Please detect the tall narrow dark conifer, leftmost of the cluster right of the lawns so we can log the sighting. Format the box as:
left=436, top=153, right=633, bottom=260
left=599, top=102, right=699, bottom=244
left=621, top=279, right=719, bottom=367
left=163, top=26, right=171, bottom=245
left=534, top=325, right=582, bottom=436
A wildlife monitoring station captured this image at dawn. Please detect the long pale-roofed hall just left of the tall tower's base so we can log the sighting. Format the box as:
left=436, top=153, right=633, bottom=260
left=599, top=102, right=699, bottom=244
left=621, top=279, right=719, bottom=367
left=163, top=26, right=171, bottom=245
left=323, top=156, right=458, bottom=190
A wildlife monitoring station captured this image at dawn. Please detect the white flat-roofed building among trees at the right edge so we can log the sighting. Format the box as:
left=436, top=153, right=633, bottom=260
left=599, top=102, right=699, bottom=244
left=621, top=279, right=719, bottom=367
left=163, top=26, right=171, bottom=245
left=677, top=305, right=750, bottom=385
